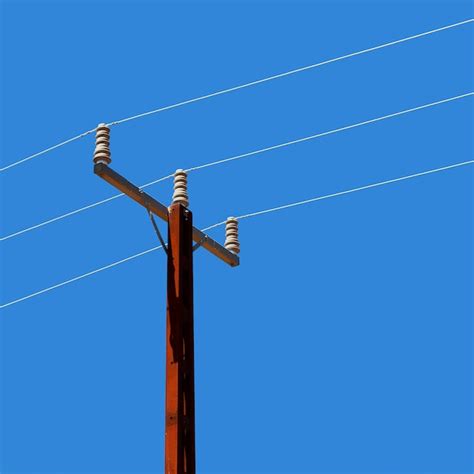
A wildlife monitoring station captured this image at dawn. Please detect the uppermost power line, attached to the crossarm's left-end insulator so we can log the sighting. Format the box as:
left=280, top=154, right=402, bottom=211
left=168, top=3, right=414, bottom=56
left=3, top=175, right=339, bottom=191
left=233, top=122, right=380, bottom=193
left=0, top=18, right=474, bottom=172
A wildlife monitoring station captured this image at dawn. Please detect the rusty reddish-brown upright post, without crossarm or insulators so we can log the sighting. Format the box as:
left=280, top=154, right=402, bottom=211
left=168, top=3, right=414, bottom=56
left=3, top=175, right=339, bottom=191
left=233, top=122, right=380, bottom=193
left=165, top=203, right=196, bottom=474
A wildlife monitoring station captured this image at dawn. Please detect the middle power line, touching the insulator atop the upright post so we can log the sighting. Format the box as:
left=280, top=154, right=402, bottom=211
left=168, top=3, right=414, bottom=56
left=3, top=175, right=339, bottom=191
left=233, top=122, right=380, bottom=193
left=0, top=92, right=474, bottom=241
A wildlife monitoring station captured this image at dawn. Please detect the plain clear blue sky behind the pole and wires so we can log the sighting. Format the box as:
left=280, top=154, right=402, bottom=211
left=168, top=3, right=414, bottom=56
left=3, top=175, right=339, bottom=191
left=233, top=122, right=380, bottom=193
left=0, top=0, right=474, bottom=473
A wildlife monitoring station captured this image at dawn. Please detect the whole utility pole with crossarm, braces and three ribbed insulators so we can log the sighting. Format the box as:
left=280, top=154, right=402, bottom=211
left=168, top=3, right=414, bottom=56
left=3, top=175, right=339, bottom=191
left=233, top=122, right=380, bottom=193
left=94, top=123, right=240, bottom=474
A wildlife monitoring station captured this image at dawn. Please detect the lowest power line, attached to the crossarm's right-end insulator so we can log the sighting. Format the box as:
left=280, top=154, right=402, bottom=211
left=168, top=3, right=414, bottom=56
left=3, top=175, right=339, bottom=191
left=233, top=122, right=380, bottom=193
left=0, top=160, right=474, bottom=309
